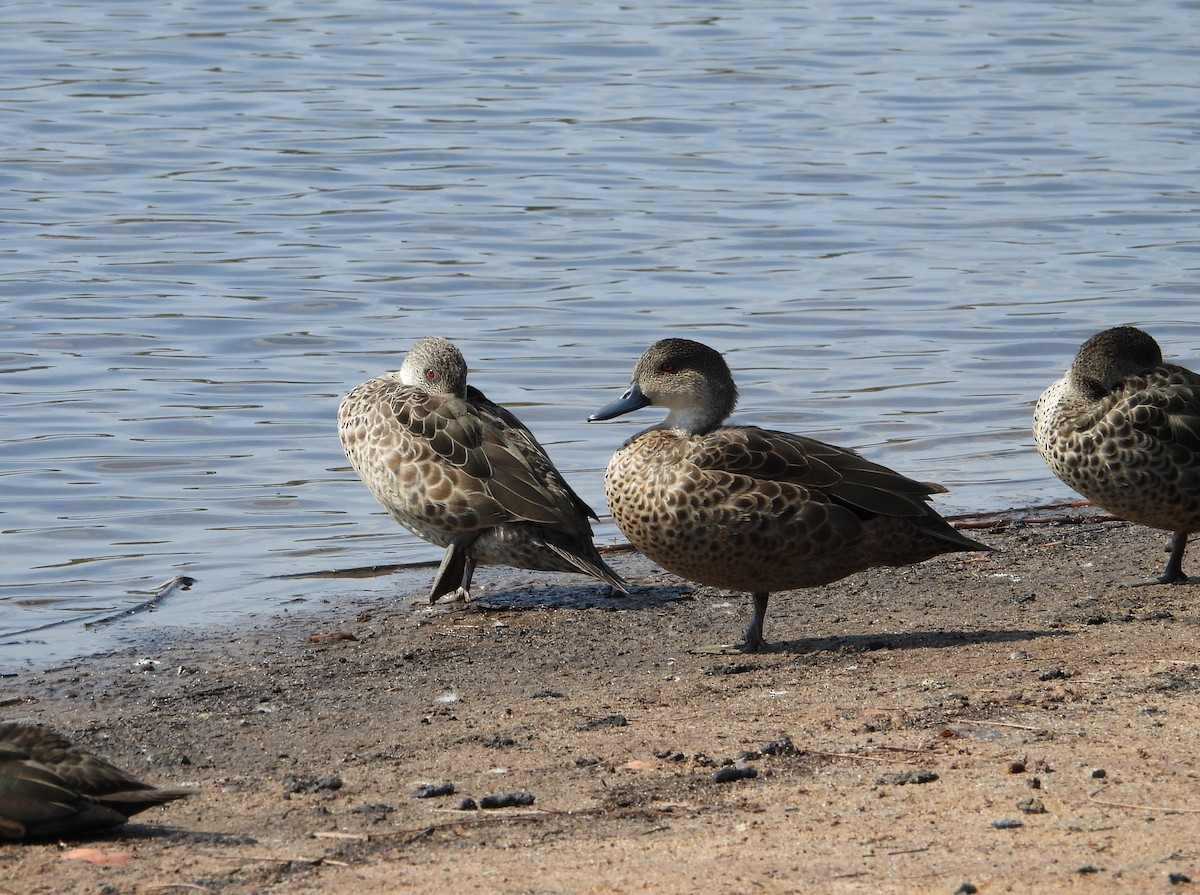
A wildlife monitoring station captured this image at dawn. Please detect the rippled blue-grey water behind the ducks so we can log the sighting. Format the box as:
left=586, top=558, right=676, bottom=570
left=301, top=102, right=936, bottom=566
left=0, top=0, right=1200, bottom=667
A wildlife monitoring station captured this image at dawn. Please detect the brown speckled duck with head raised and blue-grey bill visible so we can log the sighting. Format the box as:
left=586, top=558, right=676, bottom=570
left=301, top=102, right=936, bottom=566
left=588, top=338, right=991, bottom=653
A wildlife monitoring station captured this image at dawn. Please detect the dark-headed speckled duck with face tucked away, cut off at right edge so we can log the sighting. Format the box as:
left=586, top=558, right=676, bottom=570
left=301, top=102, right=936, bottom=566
left=1033, top=326, right=1200, bottom=584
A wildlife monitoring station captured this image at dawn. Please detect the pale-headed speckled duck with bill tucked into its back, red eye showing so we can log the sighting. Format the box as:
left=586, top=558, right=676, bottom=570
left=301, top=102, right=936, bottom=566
left=337, top=336, right=628, bottom=603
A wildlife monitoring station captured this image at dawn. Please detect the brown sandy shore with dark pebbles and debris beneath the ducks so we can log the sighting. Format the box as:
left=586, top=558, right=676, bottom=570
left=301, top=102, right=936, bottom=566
left=0, top=513, right=1200, bottom=895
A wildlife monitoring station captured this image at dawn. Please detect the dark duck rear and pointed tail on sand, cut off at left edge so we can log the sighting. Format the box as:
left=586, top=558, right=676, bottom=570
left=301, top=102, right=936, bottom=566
left=0, top=721, right=193, bottom=840
